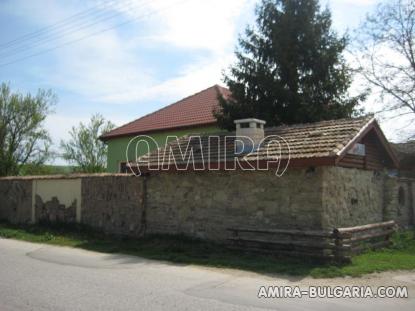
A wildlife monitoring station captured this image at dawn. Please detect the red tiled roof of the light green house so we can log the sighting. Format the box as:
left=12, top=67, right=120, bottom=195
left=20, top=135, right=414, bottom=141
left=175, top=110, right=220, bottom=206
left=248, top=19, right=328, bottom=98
left=101, top=85, right=230, bottom=140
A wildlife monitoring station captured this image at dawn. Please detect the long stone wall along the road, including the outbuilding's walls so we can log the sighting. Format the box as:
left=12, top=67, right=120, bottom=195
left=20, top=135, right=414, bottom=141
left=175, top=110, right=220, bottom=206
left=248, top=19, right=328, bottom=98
left=0, top=167, right=414, bottom=240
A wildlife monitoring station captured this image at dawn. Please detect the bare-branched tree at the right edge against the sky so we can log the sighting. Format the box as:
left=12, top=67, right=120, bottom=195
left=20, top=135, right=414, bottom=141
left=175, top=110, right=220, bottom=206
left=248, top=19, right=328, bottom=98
left=356, top=0, right=415, bottom=119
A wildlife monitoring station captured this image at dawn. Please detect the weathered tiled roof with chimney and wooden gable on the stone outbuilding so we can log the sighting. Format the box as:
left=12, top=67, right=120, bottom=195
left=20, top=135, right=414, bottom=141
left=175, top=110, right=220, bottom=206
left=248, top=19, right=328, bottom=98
left=139, top=116, right=398, bottom=171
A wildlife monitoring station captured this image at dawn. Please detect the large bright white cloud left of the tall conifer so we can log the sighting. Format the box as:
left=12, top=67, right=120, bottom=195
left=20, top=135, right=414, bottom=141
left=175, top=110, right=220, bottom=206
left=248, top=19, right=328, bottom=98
left=54, top=0, right=252, bottom=103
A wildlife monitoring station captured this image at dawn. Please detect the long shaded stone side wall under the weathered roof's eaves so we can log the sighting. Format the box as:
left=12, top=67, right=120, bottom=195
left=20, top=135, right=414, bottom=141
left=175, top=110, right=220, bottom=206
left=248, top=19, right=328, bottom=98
left=147, top=169, right=322, bottom=239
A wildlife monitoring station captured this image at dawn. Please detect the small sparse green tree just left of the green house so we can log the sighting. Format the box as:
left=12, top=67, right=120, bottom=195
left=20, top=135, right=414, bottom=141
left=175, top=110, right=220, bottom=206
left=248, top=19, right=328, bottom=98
left=61, top=114, right=114, bottom=173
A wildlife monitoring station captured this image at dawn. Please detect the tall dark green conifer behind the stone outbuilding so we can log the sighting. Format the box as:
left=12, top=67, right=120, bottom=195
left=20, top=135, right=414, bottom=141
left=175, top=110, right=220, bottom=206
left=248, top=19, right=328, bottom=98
left=215, top=0, right=364, bottom=129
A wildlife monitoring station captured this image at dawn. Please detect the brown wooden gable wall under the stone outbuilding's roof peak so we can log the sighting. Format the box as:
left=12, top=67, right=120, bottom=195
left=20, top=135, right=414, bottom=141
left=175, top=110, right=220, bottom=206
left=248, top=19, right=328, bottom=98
left=338, top=130, right=391, bottom=170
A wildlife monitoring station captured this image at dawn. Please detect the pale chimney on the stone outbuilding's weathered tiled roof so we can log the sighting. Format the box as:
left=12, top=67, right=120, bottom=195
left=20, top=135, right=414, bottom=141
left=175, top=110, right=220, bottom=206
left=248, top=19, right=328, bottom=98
left=233, top=118, right=265, bottom=153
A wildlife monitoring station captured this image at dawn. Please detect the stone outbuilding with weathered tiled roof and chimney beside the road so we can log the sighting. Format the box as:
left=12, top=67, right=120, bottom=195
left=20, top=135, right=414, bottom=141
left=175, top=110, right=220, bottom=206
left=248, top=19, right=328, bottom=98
left=130, top=117, right=414, bottom=232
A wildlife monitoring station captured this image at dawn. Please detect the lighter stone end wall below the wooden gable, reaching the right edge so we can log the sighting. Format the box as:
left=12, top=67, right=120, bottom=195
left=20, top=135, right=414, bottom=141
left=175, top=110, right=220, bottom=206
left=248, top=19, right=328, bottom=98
left=322, top=167, right=415, bottom=228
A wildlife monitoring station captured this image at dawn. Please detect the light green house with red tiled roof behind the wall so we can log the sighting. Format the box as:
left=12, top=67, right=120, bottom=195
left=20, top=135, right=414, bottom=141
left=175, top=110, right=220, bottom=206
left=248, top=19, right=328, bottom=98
left=101, top=85, right=230, bottom=173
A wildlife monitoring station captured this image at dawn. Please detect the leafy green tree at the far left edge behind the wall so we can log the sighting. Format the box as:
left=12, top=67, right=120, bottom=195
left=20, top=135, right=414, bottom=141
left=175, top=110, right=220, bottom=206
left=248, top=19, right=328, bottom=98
left=0, top=83, right=56, bottom=176
